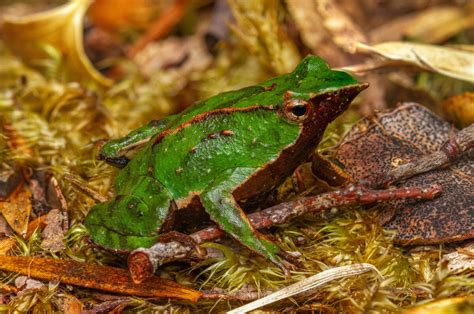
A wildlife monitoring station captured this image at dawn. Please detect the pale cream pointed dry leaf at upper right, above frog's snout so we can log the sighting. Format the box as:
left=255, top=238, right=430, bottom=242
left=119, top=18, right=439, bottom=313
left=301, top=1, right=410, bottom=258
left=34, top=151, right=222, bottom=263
left=356, top=41, right=474, bottom=83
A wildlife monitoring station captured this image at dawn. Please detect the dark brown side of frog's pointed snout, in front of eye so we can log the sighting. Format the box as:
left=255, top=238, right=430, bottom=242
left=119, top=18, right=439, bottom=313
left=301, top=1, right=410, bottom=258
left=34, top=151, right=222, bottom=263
left=309, top=83, right=369, bottom=124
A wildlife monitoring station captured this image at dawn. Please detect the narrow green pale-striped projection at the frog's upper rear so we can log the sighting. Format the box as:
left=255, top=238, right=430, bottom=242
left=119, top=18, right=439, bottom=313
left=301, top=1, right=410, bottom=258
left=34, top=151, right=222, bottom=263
left=97, top=116, right=172, bottom=168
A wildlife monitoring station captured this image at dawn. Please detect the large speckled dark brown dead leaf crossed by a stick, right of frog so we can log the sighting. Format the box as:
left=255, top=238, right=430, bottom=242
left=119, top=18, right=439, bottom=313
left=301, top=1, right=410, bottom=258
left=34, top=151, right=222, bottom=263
left=335, top=103, right=474, bottom=244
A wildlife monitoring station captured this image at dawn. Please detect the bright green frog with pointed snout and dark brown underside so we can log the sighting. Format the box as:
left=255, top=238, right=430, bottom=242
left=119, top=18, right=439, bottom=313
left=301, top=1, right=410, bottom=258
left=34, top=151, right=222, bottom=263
left=85, top=56, right=367, bottom=266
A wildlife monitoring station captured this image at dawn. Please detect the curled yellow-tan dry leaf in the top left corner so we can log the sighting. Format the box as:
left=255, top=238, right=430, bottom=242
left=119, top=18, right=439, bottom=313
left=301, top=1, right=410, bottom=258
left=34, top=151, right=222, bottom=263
left=2, top=0, right=112, bottom=86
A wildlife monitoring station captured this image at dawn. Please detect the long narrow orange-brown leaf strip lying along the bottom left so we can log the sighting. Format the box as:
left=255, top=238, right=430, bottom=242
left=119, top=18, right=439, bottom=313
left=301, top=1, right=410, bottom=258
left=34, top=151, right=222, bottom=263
left=0, top=256, right=201, bottom=302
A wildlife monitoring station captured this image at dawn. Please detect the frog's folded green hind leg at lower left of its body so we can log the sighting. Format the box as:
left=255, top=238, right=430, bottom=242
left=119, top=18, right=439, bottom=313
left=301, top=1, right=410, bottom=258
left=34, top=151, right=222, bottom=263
left=85, top=176, right=175, bottom=250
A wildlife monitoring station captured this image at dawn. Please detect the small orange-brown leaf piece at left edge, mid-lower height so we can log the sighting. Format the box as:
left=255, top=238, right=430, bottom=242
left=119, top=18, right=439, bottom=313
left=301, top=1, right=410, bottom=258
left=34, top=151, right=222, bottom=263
left=0, top=186, right=31, bottom=236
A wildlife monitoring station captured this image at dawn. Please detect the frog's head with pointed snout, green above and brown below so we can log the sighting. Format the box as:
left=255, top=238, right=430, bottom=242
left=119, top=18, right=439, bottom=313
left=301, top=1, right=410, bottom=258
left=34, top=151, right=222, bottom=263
left=270, top=56, right=368, bottom=134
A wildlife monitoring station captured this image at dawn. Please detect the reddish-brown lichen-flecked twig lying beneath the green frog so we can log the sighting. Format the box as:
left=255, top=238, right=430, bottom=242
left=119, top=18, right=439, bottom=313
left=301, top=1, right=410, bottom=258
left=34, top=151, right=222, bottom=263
left=128, top=185, right=441, bottom=283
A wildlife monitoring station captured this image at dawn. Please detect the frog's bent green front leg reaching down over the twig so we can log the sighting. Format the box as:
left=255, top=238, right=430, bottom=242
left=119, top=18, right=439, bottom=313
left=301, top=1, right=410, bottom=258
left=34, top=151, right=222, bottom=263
left=201, top=168, right=286, bottom=270
